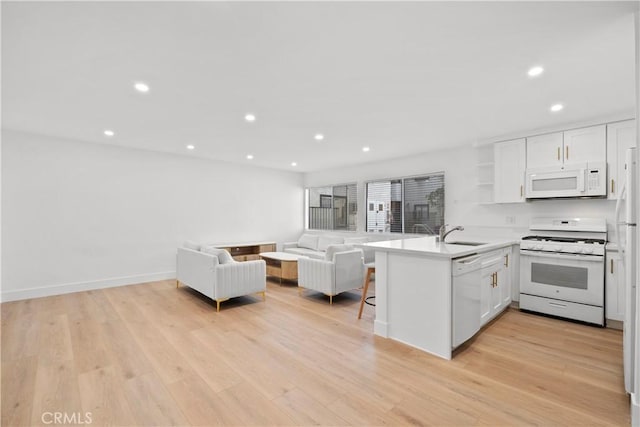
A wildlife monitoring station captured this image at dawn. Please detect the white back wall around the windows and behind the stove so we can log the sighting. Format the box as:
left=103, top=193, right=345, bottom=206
left=304, top=145, right=615, bottom=239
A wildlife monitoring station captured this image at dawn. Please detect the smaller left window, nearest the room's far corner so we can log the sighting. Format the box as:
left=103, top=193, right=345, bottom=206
left=307, top=184, right=358, bottom=231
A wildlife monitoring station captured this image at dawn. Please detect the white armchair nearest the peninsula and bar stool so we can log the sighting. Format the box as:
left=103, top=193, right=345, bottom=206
left=298, top=245, right=364, bottom=304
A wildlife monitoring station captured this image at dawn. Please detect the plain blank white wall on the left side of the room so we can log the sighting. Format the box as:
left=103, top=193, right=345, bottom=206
left=1, top=131, right=304, bottom=301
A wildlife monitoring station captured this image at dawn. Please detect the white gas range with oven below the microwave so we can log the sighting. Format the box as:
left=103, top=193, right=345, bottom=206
left=520, top=218, right=607, bottom=326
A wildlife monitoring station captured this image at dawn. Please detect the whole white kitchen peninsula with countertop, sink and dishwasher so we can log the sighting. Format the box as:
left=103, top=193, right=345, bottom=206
left=362, top=236, right=517, bottom=359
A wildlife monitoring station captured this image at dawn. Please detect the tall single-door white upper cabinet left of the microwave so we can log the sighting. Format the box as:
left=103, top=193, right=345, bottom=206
left=493, top=138, right=526, bottom=203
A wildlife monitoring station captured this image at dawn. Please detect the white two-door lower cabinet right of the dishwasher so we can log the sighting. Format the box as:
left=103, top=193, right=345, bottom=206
left=480, top=247, right=511, bottom=325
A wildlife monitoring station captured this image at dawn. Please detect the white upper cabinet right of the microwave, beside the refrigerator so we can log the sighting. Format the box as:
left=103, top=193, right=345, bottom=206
left=607, top=120, right=636, bottom=199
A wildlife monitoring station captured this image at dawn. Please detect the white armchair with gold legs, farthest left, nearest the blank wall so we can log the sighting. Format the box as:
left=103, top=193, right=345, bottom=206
left=176, top=248, right=267, bottom=311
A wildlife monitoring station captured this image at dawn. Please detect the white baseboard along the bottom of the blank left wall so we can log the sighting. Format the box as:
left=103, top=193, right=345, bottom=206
left=0, top=271, right=176, bottom=302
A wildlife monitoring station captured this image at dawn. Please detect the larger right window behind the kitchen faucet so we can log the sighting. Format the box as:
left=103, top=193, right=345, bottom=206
left=367, top=173, right=444, bottom=234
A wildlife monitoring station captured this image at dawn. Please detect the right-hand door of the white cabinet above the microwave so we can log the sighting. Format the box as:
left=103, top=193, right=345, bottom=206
left=563, top=125, right=607, bottom=165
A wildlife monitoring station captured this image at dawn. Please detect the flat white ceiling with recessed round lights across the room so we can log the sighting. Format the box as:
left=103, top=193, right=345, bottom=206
left=2, top=2, right=638, bottom=172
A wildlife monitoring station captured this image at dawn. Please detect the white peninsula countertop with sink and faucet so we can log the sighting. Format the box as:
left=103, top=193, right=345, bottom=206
left=357, top=236, right=520, bottom=259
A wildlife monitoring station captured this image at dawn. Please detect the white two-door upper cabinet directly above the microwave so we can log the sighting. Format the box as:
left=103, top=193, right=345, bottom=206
left=527, top=125, right=607, bottom=168
